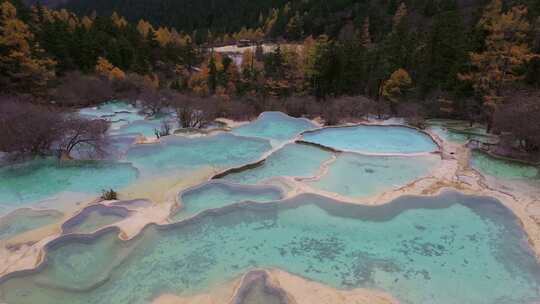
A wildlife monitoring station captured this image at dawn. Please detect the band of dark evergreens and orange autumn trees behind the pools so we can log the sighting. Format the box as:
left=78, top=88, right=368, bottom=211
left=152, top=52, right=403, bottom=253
left=0, top=0, right=540, bottom=157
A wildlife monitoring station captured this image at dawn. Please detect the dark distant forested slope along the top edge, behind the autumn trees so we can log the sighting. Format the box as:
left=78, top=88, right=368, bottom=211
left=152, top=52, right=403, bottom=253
left=49, top=0, right=540, bottom=41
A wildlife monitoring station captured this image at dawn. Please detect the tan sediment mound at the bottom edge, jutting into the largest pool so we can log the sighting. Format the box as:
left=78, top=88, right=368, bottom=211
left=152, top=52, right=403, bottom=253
left=152, top=269, right=399, bottom=304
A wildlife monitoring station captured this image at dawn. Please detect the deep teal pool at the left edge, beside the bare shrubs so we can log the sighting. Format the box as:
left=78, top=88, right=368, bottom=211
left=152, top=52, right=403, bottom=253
left=0, top=159, right=138, bottom=213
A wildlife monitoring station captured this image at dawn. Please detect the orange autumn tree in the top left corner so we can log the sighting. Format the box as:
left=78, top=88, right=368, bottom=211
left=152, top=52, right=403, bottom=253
left=0, top=1, right=56, bottom=94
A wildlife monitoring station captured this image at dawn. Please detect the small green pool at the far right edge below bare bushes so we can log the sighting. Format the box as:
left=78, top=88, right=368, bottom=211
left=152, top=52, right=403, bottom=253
left=471, top=150, right=540, bottom=182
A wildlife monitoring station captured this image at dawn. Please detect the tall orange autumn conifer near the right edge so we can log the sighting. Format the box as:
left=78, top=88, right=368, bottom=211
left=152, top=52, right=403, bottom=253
left=459, top=0, right=538, bottom=129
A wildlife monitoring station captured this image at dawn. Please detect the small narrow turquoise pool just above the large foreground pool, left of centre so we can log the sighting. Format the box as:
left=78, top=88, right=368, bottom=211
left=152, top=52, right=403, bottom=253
left=173, top=182, right=283, bottom=220
